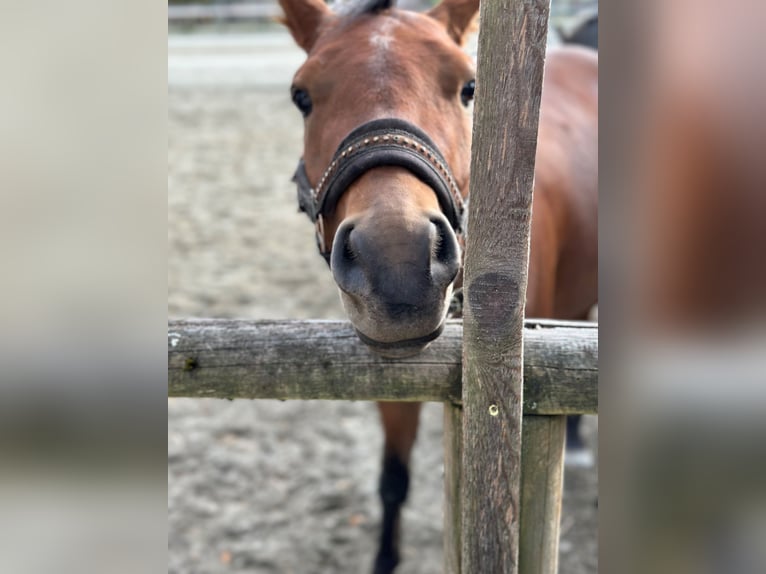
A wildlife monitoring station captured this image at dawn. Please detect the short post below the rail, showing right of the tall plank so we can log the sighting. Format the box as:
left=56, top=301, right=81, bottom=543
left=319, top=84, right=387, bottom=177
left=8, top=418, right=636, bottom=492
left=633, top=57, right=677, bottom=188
left=519, top=416, right=566, bottom=574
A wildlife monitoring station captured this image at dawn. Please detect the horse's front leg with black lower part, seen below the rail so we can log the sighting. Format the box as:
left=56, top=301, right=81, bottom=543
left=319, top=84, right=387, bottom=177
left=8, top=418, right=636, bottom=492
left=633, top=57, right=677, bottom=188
left=374, top=403, right=420, bottom=574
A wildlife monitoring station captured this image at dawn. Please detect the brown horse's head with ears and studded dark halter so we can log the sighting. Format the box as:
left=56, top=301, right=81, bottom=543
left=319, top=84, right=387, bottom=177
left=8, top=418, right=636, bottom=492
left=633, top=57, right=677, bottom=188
left=280, top=0, right=479, bottom=357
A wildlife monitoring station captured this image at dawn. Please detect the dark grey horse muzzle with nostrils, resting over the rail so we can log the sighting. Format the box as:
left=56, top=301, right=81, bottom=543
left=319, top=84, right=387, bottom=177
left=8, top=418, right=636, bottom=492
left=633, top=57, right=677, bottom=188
left=331, top=213, right=460, bottom=357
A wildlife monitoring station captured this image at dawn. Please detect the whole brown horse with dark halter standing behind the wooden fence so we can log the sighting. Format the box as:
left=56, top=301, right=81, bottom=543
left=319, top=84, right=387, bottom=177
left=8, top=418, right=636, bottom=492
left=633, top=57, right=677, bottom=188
left=280, top=0, right=598, bottom=572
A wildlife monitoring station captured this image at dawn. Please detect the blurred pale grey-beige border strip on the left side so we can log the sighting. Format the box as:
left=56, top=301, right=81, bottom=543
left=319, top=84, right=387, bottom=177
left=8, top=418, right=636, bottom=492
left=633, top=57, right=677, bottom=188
left=0, top=0, right=167, bottom=574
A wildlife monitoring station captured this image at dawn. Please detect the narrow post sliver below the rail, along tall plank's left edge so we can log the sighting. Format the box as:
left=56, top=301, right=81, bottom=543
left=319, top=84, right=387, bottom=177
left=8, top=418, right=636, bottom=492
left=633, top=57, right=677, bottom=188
left=443, top=403, right=463, bottom=574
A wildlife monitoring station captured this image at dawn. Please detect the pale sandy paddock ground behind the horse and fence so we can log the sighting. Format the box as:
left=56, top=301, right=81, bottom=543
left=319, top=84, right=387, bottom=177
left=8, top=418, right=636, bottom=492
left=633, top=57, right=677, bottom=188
left=168, top=30, right=598, bottom=574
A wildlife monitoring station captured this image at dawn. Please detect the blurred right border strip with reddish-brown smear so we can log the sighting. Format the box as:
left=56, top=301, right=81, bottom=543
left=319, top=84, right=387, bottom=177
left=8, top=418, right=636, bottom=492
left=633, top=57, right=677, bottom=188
left=601, top=0, right=766, bottom=574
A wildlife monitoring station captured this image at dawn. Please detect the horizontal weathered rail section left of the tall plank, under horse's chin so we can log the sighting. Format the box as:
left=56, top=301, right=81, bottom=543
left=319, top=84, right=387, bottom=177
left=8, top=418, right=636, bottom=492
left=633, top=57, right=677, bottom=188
left=168, top=320, right=460, bottom=401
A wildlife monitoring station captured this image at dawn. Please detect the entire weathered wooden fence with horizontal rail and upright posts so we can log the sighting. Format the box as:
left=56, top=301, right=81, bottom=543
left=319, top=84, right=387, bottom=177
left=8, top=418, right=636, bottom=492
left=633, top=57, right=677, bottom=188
left=168, top=0, right=598, bottom=574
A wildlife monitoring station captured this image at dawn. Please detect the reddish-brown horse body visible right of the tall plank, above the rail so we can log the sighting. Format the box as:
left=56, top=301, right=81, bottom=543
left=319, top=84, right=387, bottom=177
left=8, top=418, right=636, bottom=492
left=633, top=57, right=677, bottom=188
left=526, top=47, right=598, bottom=319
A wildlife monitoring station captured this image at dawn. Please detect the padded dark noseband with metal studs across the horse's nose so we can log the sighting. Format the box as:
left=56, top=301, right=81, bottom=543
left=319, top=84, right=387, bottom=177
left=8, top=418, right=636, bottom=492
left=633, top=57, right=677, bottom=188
left=293, top=118, right=465, bottom=265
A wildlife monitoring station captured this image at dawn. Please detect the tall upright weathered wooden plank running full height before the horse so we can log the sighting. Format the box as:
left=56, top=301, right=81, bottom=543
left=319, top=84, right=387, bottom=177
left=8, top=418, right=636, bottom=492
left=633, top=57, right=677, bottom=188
left=461, top=0, right=549, bottom=574
